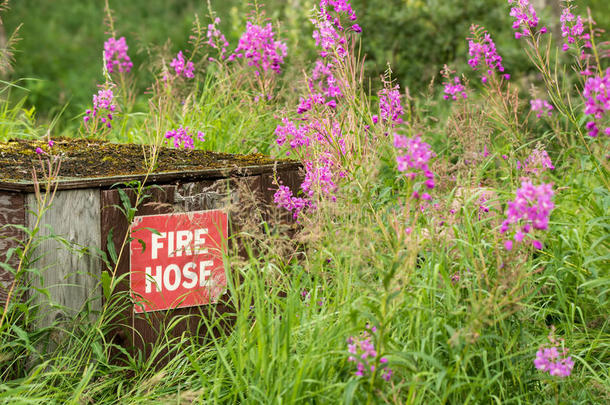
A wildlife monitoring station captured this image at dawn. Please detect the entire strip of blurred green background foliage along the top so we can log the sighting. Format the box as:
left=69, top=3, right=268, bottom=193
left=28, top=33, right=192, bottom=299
left=4, top=0, right=610, bottom=123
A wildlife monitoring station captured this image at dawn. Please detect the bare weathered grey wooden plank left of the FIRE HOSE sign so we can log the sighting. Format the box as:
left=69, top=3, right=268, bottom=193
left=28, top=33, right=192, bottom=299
left=26, top=189, right=102, bottom=327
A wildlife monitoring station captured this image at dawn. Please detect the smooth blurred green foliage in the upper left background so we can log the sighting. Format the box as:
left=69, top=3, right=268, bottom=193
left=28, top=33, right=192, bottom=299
left=5, top=0, right=200, bottom=116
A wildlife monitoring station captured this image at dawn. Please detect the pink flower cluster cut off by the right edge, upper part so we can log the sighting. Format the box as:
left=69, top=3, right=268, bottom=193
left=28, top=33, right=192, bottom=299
left=582, top=68, right=610, bottom=137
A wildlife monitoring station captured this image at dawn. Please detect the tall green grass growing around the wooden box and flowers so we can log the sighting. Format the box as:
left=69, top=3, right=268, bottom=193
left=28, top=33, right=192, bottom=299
left=0, top=0, right=610, bottom=404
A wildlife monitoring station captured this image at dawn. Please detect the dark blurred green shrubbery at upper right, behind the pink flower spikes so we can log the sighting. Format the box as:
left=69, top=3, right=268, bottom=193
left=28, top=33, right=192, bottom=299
left=356, top=0, right=516, bottom=91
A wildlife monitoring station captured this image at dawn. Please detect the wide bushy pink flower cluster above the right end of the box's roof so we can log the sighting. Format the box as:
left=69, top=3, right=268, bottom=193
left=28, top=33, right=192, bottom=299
left=228, top=21, right=287, bottom=76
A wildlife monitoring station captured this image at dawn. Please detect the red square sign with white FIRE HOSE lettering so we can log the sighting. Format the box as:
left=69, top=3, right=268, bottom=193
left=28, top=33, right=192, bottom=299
left=130, top=210, right=228, bottom=313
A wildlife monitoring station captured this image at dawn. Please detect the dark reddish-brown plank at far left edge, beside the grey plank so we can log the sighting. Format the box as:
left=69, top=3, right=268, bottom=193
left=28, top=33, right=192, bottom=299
left=0, top=191, right=25, bottom=305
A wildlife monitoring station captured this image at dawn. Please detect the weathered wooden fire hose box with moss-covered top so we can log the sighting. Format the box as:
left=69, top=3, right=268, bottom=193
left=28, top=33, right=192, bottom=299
left=0, top=138, right=301, bottom=352
